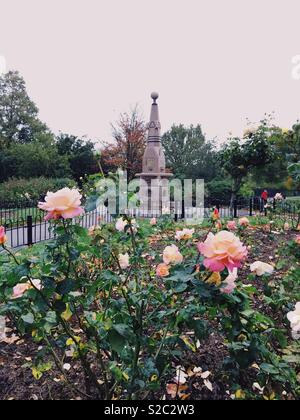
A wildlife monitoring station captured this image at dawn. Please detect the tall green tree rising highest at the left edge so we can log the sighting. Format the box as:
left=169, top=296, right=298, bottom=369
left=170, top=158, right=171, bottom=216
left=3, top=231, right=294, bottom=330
left=0, top=71, right=47, bottom=146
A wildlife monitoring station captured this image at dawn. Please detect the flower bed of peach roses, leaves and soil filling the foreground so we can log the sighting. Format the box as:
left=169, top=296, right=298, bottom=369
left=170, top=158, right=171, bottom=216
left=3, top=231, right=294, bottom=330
left=0, top=190, right=300, bottom=400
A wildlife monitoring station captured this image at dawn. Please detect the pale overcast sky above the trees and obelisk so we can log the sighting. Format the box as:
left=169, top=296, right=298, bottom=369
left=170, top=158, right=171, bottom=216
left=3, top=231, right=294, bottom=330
left=0, top=0, right=300, bottom=146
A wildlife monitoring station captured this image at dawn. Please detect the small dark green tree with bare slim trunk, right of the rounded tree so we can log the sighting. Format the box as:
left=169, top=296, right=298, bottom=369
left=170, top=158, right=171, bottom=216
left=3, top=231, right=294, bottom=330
left=219, top=125, right=274, bottom=204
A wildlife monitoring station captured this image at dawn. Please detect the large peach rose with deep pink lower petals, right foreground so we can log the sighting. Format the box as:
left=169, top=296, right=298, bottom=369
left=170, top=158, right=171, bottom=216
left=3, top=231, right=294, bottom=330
left=198, top=230, right=248, bottom=271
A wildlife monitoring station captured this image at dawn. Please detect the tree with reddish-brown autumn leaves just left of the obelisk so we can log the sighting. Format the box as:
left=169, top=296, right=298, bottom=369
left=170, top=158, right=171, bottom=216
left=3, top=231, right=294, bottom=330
left=101, top=107, right=146, bottom=180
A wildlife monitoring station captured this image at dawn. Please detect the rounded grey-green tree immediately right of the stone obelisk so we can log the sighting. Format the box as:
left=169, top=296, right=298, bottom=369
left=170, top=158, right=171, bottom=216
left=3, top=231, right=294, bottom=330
left=162, top=124, right=217, bottom=181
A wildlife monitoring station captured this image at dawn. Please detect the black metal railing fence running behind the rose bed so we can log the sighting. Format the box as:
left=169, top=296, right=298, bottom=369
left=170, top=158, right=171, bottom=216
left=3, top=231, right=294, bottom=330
left=0, top=197, right=300, bottom=248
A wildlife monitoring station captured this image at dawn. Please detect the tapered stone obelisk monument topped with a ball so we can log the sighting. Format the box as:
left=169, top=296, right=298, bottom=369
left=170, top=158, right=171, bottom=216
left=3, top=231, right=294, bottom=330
left=137, top=92, right=173, bottom=214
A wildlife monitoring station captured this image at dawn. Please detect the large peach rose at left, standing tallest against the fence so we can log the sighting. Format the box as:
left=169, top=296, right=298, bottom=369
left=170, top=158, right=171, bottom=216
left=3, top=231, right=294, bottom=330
left=38, top=188, right=84, bottom=220
